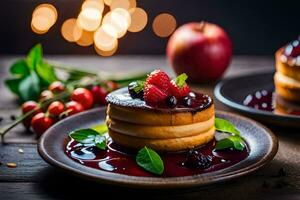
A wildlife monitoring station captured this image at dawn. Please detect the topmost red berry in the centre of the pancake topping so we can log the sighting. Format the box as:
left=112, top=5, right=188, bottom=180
left=145, top=69, right=170, bottom=94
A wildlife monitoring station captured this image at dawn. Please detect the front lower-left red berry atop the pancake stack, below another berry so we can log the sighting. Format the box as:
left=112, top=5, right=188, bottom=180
left=144, top=84, right=168, bottom=105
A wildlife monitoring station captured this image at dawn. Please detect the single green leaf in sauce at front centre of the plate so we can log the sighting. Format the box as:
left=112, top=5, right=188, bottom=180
left=136, top=147, right=164, bottom=175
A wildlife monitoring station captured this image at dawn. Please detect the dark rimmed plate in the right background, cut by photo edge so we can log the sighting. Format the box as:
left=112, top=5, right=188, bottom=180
left=214, top=71, right=300, bottom=127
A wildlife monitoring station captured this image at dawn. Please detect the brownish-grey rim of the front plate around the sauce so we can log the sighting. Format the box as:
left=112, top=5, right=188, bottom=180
left=38, top=108, right=278, bottom=188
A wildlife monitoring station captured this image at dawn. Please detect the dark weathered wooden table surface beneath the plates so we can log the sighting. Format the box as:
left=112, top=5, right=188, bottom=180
left=0, top=56, right=300, bottom=200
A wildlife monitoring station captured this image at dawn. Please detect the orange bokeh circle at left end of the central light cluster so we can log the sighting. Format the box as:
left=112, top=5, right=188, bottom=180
left=61, top=18, right=83, bottom=42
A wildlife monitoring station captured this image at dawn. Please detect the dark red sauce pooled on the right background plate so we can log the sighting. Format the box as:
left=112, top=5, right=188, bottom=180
left=243, top=90, right=300, bottom=115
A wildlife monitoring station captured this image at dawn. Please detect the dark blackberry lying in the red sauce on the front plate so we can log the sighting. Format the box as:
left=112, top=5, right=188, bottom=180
left=183, top=150, right=212, bottom=169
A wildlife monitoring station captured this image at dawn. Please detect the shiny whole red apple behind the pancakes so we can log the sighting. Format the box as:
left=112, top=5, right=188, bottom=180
left=167, top=22, right=232, bottom=83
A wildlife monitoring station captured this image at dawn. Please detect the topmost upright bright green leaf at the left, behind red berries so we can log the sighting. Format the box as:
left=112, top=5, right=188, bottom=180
left=26, top=44, right=43, bottom=70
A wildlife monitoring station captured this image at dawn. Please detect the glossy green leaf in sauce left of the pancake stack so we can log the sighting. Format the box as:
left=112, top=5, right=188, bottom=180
left=69, top=129, right=107, bottom=150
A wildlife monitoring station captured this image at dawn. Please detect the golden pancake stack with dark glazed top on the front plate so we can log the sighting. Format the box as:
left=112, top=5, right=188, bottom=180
left=107, top=89, right=215, bottom=151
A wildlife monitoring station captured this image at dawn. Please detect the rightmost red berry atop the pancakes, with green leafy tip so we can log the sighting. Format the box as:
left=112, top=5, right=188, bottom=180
left=170, top=73, right=190, bottom=99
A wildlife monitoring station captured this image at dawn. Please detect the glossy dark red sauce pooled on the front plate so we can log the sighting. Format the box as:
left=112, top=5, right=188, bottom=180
left=66, top=139, right=249, bottom=177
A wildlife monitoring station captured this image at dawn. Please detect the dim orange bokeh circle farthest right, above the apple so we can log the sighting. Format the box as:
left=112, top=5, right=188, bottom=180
left=152, top=13, right=177, bottom=37
